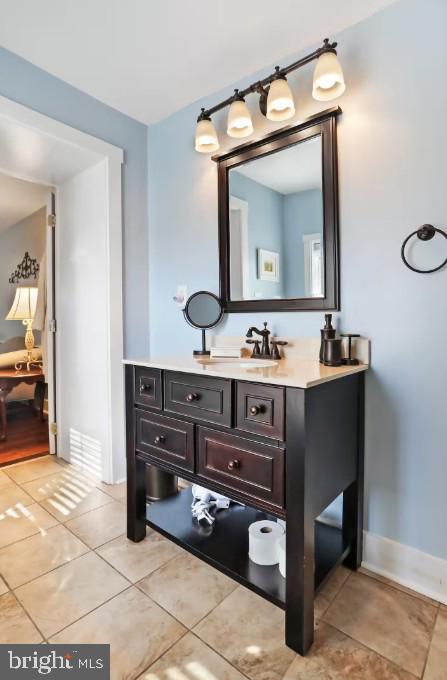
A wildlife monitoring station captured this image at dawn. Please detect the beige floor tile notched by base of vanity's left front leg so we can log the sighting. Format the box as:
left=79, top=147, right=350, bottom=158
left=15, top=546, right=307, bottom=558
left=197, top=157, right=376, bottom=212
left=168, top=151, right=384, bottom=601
left=97, top=529, right=183, bottom=583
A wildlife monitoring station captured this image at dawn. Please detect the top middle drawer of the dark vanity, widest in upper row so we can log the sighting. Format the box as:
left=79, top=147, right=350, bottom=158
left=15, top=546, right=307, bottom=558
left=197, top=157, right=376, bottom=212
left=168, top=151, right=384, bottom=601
left=165, top=371, right=231, bottom=427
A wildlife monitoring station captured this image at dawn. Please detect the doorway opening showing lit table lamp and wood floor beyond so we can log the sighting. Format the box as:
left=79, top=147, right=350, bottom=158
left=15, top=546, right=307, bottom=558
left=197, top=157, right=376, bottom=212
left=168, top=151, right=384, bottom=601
left=0, top=173, right=50, bottom=466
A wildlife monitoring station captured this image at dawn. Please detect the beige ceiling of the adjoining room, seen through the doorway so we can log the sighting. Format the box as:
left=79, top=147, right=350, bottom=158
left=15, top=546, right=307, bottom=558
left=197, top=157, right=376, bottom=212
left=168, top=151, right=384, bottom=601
left=0, top=173, right=48, bottom=232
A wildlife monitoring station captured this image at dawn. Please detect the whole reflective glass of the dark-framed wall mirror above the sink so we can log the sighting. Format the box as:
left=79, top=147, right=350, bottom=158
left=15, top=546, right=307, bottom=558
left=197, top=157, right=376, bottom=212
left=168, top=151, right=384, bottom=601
left=228, top=135, right=324, bottom=300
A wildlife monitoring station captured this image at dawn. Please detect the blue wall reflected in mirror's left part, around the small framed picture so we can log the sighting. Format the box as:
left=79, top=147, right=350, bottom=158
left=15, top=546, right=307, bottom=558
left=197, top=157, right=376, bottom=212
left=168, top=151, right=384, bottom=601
left=229, top=170, right=284, bottom=299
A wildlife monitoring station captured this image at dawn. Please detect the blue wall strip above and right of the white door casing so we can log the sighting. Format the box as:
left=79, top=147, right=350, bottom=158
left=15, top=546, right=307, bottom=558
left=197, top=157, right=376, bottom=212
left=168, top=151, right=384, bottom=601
left=0, top=48, right=149, bottom=356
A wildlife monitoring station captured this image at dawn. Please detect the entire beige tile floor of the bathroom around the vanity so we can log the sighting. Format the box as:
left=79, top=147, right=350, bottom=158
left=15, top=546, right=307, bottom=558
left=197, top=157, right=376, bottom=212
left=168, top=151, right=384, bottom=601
left=0, top=456, right=447, bottom=680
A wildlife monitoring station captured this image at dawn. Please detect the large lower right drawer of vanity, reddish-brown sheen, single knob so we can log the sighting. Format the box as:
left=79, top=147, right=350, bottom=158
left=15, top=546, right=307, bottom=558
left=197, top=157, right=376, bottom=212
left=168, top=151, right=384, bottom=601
left=197, top=427, right=285, bottom=508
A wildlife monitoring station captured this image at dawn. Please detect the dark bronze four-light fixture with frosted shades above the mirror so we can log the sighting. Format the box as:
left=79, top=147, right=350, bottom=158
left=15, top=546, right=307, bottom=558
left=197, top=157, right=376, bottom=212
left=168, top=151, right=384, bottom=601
left=195, top=38, right=346, bottom=153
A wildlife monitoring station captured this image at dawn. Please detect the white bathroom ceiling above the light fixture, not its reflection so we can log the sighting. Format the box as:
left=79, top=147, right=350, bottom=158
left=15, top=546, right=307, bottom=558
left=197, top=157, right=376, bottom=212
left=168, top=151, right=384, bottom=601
left=0, top=0, right=394, bottom=124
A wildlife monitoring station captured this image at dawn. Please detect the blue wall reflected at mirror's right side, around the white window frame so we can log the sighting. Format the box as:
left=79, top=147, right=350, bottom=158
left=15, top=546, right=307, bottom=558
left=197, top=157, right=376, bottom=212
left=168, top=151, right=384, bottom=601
left=283, top=189, right=323, bottom=297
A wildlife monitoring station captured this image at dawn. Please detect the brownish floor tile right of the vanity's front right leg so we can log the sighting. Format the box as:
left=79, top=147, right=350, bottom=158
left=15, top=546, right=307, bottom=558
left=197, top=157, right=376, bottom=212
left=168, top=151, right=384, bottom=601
left=323, top=573, right=437, bottom=676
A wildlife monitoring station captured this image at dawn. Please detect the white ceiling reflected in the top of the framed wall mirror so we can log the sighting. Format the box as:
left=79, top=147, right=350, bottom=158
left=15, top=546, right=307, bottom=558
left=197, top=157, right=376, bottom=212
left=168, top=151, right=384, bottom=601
left=234, top=137, right=321, bottom=194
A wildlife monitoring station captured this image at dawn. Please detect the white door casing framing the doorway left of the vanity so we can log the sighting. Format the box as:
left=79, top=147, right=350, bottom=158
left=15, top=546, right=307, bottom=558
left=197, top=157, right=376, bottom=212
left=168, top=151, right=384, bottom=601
left=0, top=96, right=125, bottom=483
